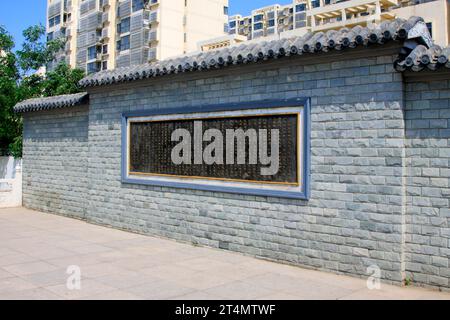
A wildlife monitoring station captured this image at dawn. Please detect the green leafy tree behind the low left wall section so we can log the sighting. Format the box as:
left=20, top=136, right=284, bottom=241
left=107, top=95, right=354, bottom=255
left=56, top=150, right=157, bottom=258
left=0, top=25, right=84, bottom=157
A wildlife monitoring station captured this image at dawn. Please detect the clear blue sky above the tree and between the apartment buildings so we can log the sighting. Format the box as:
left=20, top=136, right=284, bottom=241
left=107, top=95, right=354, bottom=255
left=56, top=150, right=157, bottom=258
left=0, top=0, right=292, bottom=49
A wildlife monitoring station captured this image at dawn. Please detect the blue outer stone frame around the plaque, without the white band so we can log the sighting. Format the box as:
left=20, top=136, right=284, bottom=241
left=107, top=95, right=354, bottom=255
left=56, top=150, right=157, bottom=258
left=121, top=98, right=311, bottom=200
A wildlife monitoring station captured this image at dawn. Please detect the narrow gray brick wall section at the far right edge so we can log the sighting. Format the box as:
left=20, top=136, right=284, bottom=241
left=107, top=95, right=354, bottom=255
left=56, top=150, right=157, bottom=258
left=405, top=78, right=450, bottom=287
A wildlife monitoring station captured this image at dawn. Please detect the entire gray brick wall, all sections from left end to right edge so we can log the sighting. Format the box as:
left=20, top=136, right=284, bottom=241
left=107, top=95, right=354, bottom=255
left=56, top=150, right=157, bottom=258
left=20, top=56, right=450, bottom=287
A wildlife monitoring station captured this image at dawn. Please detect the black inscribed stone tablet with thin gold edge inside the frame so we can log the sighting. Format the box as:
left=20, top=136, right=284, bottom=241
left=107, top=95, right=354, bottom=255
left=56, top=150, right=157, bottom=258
left=129, top=113, right=299, bottom=185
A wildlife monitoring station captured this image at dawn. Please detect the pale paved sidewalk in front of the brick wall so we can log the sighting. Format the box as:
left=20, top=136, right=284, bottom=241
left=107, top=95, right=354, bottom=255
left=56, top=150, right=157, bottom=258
left=0, top=208, right=450, bottom=300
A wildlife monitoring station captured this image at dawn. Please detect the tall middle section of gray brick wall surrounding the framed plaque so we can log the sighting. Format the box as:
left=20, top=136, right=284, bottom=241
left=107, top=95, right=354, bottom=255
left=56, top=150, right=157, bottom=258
left=87, top=56, right=404, bottom=282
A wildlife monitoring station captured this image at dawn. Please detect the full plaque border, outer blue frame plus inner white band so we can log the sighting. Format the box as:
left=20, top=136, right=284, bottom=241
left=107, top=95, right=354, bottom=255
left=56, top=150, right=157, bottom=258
left=121, top=98, right=311, bottom=200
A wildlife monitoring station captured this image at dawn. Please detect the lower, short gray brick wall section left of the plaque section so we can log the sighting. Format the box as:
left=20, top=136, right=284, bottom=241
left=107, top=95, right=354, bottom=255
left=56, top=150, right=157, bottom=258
left=23, top=106, right=89, bottom=218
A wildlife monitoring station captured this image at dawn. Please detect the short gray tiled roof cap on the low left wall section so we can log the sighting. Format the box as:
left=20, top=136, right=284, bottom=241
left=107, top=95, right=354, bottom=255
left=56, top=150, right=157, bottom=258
left=14, top=92, right=89, bottom=113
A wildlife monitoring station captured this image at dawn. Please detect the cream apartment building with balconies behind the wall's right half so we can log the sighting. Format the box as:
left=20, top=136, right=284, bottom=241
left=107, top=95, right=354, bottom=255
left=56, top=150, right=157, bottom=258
left=227, top=0, right=450, bottom=46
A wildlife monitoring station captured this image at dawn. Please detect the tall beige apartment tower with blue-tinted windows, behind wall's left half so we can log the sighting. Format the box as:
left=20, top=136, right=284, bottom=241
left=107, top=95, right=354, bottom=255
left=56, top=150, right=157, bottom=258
left=47, top=0, right=228, bottom=73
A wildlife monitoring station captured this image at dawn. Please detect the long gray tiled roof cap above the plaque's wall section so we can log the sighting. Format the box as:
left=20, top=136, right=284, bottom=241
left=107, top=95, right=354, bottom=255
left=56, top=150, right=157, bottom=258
left=80, top=17, right=423, bottom=87
